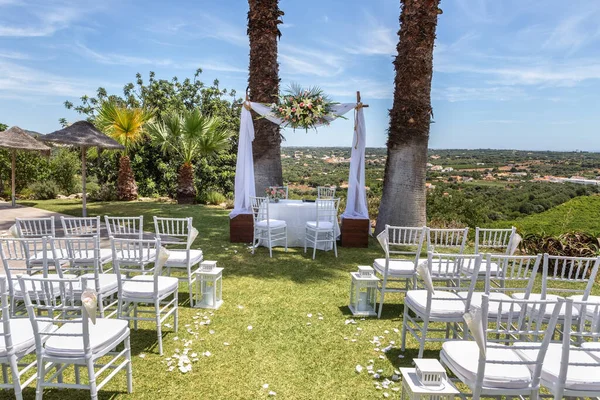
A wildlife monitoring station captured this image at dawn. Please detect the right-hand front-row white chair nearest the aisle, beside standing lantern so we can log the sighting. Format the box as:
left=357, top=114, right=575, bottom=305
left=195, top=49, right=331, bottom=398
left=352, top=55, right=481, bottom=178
left=373, top=225, right=427, bottom=318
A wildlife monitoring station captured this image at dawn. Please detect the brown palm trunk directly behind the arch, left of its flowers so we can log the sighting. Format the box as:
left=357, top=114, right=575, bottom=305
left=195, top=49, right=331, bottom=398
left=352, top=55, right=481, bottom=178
left=248, top=0, right=283, bottom=193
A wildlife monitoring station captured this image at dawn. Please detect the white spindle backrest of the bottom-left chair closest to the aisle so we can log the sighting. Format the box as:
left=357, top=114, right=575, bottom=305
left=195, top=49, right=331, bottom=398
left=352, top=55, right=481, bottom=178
left=19, top=276, right=92, bottom=358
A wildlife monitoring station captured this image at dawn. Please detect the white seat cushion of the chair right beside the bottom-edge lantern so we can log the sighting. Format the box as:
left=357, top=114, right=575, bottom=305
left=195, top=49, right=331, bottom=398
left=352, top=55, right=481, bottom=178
left=442, top=340, right=531, bottom=389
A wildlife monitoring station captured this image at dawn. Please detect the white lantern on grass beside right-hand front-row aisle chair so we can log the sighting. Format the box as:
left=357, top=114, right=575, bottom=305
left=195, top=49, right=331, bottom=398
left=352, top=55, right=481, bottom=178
left=348, top=266, right=379, bottom=317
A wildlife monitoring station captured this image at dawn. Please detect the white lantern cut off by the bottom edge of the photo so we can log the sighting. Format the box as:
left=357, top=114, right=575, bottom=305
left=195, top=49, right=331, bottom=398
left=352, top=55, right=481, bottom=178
left=400, top=359, right=460, bottom=400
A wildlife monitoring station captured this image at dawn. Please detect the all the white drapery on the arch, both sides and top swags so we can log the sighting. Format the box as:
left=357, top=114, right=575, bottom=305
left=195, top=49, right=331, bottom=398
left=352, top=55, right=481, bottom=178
left=229, top=101, right=369, bottom=223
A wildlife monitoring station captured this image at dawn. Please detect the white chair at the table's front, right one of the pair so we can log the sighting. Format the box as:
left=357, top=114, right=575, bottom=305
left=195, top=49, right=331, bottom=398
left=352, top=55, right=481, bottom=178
left=304, top=199, right=340, bottom=260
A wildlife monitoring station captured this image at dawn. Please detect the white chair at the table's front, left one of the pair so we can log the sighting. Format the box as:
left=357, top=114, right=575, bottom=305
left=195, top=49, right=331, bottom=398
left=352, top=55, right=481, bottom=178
left=250, top=197, right=287, bottom=257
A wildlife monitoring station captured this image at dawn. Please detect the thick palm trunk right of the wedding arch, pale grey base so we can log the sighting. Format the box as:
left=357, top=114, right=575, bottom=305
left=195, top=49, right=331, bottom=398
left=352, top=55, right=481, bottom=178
left=376, top=0, right=441, bottom=233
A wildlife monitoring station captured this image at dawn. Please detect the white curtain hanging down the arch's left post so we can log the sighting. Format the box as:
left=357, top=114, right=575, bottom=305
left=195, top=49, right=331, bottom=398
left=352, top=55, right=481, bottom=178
left=229, top=107, right=256, bottom=218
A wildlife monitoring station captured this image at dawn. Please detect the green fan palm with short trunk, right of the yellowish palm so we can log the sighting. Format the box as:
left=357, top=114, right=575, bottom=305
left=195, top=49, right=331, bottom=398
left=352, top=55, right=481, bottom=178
left=148, top=109, right=233, bottom=204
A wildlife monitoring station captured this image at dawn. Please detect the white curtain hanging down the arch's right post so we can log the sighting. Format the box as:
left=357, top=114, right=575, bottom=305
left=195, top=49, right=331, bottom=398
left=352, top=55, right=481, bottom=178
left=342, top=107, right=369, bottom=219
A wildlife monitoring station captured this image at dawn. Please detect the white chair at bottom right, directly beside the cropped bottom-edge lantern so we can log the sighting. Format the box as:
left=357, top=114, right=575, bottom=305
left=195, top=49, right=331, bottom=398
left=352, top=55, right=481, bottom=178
left=440, top=295, right=564, bottom=400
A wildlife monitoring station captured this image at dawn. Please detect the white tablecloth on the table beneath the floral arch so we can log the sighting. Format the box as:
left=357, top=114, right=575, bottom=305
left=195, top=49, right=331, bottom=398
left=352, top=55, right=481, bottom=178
left=261, top=200, right=340, bottom=250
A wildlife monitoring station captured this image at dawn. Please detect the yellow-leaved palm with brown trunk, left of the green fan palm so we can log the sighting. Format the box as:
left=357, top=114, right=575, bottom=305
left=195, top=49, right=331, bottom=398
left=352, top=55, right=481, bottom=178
left=95, top=101, right=152, bottom=200
